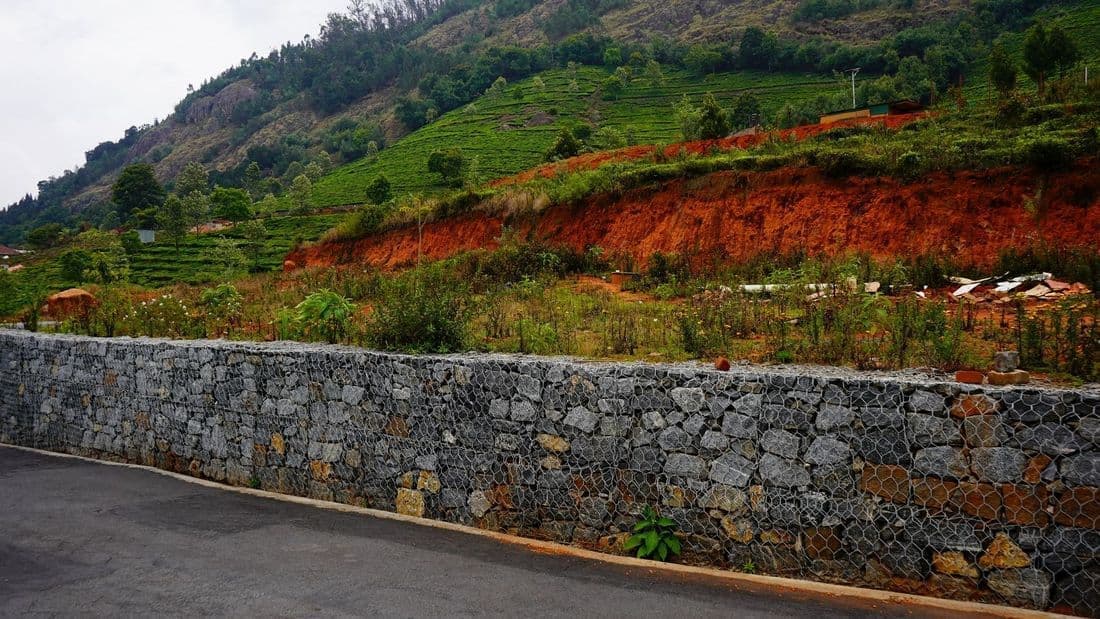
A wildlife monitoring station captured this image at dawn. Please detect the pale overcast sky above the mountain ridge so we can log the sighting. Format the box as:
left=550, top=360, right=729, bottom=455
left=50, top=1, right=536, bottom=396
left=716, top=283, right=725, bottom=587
left=0, top=0, right=348, bottom=208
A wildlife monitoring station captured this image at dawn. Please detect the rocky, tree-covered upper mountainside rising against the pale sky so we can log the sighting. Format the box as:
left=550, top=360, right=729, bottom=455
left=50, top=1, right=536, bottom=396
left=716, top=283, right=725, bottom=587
left=0, top=0, right=990, bottom=242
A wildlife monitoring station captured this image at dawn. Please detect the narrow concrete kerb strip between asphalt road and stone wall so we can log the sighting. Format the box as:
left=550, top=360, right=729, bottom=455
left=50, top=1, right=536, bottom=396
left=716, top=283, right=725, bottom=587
left=0, top=443, right=1067, bottom=619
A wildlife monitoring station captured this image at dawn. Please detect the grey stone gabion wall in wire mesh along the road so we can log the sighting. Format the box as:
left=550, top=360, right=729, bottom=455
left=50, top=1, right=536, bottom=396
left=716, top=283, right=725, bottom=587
left=0, top=332, right=1100, bottom=616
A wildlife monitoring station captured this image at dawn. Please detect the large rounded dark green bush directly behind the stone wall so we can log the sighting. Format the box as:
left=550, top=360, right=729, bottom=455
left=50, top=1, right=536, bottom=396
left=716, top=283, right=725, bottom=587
left=369, top=265, right=469, bottom=353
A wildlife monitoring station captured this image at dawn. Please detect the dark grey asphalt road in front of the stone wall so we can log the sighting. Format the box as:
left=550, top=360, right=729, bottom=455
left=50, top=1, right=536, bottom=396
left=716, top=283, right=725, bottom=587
left=0, top=446, right=981, bottom=619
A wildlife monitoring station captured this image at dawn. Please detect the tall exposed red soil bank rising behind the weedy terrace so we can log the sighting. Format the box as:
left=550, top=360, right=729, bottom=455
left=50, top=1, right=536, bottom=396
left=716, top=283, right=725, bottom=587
left=288, top=159, right=1100, bottom=268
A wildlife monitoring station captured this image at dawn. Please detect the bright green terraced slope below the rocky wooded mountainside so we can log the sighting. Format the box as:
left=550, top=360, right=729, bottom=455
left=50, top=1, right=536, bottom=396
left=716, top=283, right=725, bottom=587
left=314, top=67, right=844, bottom=207
